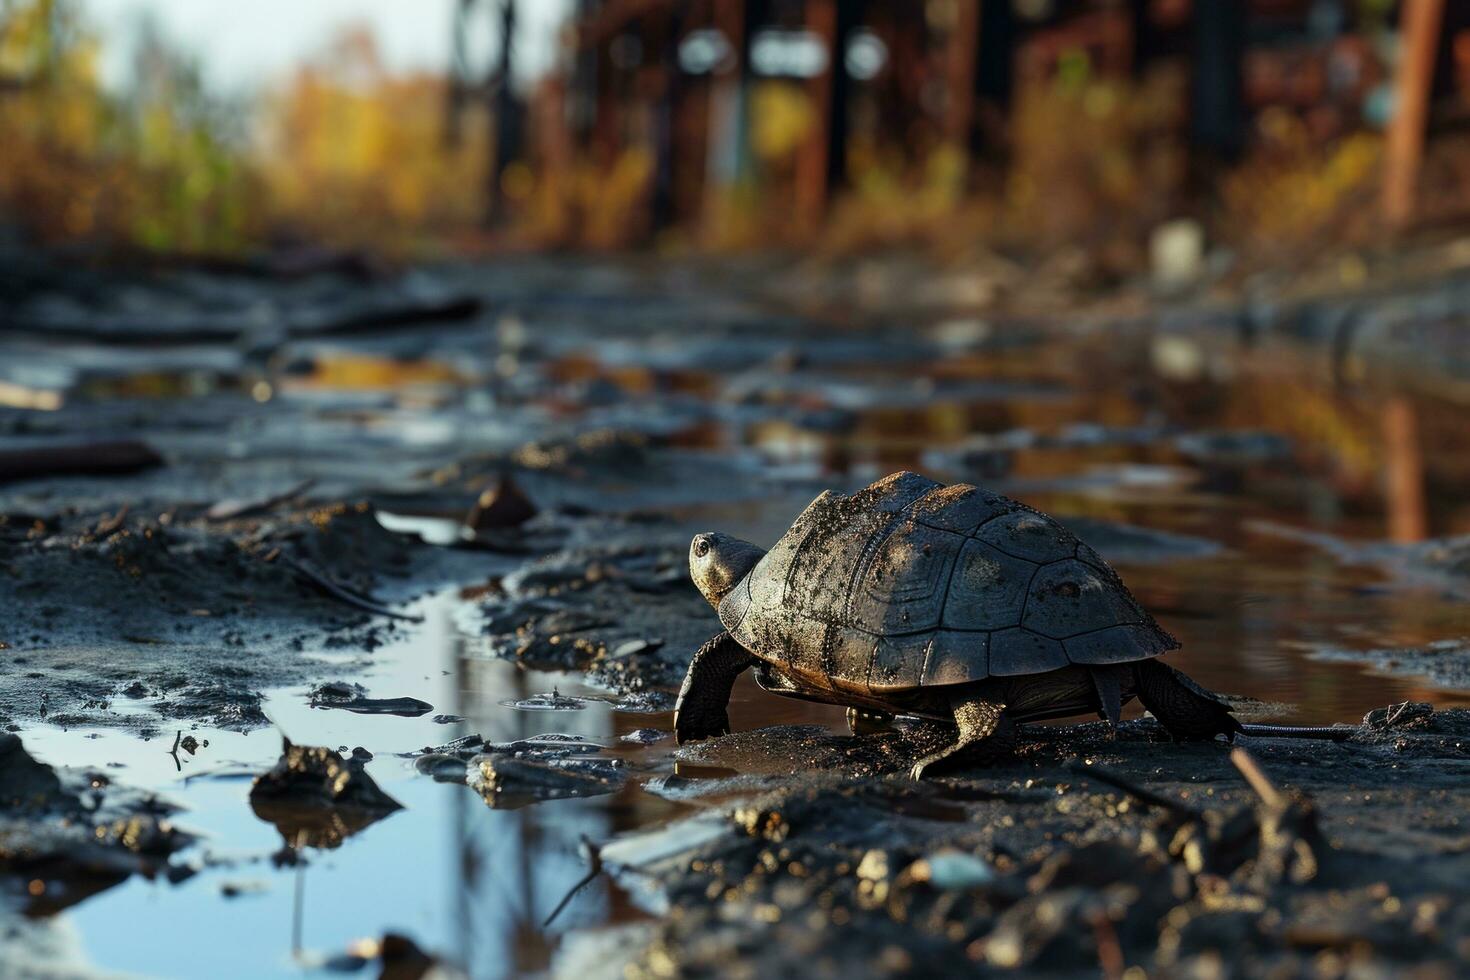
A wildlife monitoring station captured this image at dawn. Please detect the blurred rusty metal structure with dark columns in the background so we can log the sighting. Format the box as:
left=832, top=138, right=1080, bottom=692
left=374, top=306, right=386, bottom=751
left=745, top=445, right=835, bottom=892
left=451, top=0, right=1470, bottom=238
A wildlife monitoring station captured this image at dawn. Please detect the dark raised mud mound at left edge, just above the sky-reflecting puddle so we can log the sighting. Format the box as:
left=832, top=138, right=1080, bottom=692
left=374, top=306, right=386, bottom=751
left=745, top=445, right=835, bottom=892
left=0, top=502, right=492, bottom=736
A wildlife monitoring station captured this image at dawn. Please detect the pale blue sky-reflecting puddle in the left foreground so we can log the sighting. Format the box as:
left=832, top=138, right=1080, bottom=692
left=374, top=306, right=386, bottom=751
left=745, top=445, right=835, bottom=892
left=4, top=597, right=655, bottom=977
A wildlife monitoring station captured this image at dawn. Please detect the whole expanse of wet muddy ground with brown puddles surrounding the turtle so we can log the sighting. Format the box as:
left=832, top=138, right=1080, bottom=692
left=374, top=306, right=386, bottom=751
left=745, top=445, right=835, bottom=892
left=0, top=251, right=1470, bottom=976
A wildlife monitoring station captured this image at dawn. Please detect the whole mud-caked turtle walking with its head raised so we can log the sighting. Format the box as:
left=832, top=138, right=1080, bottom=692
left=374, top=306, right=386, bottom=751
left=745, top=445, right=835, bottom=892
left=675, top=473, right=1239, bottom=777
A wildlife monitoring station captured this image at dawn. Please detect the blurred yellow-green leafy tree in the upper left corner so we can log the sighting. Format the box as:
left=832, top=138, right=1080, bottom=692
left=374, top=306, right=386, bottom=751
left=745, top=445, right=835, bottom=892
left=0, top=0, right=251, bottom=251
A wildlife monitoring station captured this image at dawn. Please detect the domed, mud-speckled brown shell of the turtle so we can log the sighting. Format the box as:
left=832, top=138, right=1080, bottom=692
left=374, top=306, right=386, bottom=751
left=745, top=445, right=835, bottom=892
left=719, top=473, right=1179, bottom=698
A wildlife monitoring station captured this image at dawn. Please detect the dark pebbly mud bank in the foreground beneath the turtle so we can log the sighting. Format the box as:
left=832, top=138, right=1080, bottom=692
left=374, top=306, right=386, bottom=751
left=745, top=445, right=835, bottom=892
left=590, top=711, right=1470, bottom=976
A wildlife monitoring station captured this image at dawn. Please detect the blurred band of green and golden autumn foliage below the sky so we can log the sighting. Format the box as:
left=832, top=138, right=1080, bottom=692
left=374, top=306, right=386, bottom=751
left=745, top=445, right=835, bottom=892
left=0, top=0, right=485, bottom=254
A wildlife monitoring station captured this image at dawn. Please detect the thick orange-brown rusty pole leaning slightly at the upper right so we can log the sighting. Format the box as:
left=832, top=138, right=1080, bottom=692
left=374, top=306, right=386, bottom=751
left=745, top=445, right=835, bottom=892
left=1383, top=0, right=1445, bottom=228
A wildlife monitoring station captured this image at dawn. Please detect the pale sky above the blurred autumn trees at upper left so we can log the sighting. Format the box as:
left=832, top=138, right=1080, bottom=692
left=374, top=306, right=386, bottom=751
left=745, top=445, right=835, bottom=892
left=79, top=0, right=569, bottom=93
